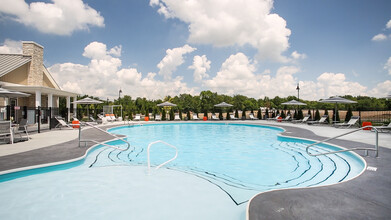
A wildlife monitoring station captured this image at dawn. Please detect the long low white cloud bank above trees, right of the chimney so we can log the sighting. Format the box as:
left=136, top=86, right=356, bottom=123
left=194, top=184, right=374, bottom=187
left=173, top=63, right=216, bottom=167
left=48, top=42, right=195, bottom=99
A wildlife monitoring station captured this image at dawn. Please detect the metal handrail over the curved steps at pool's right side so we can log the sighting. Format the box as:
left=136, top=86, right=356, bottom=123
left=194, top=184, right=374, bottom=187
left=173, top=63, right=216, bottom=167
left=305, top=125, right=379, bottom=157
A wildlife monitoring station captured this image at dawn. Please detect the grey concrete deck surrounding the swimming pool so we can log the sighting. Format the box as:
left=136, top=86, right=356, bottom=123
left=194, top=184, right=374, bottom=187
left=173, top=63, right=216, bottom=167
left=0, top=120, right=391, bottom=219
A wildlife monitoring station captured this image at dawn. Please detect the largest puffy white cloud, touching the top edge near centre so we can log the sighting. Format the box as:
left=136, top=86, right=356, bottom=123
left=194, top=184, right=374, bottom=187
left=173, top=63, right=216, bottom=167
left=150, top=0, right=291, bottom=62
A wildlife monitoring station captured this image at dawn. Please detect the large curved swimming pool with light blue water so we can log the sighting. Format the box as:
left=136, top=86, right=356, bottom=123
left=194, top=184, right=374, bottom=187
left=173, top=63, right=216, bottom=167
left=0, top=123, right=365, bottom=219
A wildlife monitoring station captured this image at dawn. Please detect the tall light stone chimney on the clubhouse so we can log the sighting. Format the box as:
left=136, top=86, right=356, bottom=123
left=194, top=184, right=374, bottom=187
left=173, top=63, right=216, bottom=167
left=22, top=41, right=43, bottom=86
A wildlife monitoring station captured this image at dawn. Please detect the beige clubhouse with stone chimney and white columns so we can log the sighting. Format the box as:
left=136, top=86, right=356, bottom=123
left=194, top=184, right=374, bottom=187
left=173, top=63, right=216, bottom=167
left=0, top=41, right=78, bottom=124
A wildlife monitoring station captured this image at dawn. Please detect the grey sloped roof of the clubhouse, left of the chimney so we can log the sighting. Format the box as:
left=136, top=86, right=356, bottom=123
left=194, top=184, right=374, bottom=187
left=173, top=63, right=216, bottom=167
left=0, top=54, right=31, bottom=77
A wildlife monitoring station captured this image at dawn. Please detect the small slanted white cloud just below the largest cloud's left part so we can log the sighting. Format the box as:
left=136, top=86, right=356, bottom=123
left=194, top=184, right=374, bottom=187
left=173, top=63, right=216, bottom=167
left=157, top=44, right=197, bottom=80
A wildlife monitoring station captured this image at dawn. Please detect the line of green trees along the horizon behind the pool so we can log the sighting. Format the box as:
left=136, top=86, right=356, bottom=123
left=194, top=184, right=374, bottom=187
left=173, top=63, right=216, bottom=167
left=69, top=90, right=391, bottom=119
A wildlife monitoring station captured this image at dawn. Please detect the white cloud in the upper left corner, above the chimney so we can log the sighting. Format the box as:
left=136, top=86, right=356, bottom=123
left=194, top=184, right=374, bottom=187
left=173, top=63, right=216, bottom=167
left=0, top=0, right=104, bottom=35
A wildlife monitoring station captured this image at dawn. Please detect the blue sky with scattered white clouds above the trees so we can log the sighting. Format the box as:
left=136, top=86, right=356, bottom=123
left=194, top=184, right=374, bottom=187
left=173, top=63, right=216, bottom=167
left=0, top=0, right=391, bottom=100
